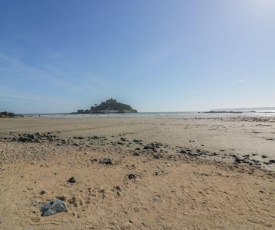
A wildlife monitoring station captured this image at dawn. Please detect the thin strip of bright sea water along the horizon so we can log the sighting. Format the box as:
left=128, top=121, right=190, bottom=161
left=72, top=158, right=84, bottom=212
left=25, top=110, right=275, bottom=119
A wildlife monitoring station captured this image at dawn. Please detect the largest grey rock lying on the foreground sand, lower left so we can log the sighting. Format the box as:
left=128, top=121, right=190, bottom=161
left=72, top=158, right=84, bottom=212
left=40, top=199, right=68, bottom=216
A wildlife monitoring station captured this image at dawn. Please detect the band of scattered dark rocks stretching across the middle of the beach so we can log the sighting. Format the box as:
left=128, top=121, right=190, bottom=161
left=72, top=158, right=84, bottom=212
left=0, top=132, right=275, bottom=170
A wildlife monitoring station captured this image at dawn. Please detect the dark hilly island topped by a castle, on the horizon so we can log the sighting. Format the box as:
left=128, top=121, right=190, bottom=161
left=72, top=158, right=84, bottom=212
left=72, top=98, right=137, bottom=114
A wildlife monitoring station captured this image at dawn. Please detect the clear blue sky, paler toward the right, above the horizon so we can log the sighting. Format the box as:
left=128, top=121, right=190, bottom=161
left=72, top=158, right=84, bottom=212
left=0, top=0, right=275, bottom=114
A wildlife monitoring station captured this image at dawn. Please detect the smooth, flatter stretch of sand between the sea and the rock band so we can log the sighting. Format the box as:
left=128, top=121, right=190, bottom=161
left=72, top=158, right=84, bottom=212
left=0, top=117, right=275, bottom=171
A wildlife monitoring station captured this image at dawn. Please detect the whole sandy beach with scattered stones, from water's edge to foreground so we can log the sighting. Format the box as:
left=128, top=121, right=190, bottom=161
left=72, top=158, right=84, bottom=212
left=0, top=117, right=275, bottom=230
